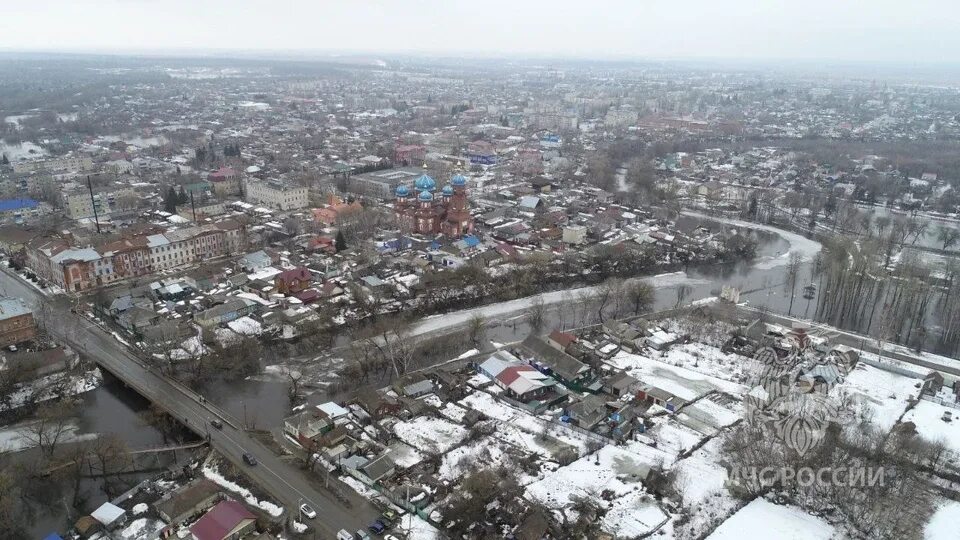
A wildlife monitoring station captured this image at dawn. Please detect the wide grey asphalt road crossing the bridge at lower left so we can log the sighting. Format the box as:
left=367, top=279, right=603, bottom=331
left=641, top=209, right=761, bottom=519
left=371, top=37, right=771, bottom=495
left=0, top=264, right=379, bottom=538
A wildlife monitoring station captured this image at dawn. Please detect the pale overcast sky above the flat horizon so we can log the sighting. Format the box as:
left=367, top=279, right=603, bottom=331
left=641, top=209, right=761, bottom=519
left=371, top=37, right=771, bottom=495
left=0, top=0, right=960, bottom=63
